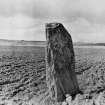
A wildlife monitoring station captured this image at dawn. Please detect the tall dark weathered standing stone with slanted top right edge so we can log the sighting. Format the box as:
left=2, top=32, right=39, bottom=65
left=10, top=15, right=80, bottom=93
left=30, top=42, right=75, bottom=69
left=46, top=23, right=79, bottom=102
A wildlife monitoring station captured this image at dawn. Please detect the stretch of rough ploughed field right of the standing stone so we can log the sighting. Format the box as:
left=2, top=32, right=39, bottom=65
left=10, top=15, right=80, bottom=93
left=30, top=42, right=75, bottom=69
left=75, top=47, right=105, bottom=96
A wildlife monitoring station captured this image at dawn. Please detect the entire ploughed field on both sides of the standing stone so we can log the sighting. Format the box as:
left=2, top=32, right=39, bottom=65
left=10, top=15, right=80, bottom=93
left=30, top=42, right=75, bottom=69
left=0, top=46, right=105, bottom=105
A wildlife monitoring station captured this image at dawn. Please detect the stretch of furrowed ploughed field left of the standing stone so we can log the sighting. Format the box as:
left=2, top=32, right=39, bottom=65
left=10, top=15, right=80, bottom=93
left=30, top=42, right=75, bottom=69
left=0, top=46, right=46, bottom=105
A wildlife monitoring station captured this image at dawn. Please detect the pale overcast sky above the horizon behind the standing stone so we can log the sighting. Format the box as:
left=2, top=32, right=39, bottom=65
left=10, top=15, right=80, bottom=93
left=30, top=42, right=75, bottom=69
left=0, top=0, right=105, bottom=42
